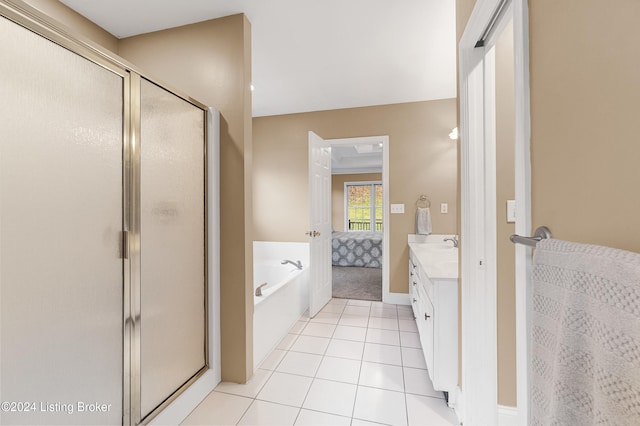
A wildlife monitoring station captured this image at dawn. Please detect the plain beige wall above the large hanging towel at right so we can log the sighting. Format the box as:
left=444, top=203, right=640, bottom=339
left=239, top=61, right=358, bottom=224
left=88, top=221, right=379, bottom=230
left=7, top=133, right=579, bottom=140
left=529, top=0, right=640, bottom=252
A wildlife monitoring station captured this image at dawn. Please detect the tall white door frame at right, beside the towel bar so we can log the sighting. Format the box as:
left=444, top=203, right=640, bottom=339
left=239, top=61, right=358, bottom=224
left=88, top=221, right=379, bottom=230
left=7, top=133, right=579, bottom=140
left=458, top=0, right=531, bottom=425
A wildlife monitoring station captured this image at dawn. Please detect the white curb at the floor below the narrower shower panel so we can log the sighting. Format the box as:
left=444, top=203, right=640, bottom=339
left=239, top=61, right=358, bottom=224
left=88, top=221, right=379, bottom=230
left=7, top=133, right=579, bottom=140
left=149, top=370, right=220, bottom=425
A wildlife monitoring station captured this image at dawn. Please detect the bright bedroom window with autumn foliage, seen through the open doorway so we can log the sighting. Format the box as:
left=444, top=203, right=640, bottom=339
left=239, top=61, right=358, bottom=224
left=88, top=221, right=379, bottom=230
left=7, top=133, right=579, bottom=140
left=344, top=182, right=382, bottom=231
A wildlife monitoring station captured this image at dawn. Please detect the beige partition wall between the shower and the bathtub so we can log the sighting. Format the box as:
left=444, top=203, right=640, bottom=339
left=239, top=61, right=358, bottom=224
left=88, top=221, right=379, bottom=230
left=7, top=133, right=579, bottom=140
left=119, top=15, right=253, bottom=382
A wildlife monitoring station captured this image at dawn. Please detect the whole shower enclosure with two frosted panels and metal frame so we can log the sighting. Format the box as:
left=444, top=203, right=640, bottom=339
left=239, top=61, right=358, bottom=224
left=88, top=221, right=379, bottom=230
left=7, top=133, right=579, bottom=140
left=0, top=1, right=217, bottom=425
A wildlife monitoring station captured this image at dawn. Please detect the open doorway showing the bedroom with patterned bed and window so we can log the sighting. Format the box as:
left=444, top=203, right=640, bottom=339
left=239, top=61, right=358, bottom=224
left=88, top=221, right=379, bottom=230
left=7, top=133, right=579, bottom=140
left=309, top=136, right=389, bottom=310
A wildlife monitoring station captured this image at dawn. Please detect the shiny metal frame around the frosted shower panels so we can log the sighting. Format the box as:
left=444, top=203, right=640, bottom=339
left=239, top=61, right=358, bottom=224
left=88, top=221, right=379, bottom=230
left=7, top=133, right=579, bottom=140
left=0, top=0, right=216, bottom=425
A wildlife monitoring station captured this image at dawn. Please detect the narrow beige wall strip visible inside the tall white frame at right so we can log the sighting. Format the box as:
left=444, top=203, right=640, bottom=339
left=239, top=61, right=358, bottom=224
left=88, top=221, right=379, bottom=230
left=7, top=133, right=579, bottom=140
left=495, top=19, right=517, bottom=406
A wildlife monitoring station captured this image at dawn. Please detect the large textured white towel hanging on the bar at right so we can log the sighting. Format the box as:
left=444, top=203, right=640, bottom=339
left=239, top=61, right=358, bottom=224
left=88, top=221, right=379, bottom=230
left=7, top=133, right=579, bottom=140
left=529, top=239, right=640, bottom=426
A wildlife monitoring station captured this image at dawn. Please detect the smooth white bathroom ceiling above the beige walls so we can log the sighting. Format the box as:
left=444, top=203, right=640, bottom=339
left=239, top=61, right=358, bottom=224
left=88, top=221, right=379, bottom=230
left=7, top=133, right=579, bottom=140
left=60, top=0, right=456, bottom=116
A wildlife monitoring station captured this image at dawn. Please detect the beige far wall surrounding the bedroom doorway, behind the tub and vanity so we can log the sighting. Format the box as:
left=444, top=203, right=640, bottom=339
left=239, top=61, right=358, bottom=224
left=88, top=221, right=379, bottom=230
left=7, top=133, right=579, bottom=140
left=253, top=99, right=457, bottom=293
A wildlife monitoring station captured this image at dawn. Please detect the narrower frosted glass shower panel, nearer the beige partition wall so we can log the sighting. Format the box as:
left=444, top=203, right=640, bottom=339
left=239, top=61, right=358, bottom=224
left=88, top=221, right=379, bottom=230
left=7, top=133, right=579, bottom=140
left=140, top=80, right=205, bottom=417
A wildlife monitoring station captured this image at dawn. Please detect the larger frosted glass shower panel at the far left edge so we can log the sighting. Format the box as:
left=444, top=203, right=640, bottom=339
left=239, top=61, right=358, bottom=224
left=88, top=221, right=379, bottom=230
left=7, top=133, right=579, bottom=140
left=0, top=17, right=123, bottom=425
